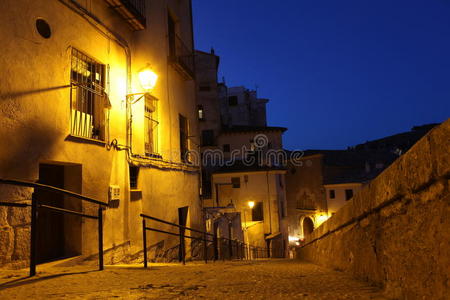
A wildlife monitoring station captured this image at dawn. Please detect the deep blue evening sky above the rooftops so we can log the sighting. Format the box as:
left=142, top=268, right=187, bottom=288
left=193, top=0, right=450, bottom=149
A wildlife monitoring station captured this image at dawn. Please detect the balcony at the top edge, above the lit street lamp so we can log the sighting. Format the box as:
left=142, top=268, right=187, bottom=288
left=105, top=0, right=146, bottom=30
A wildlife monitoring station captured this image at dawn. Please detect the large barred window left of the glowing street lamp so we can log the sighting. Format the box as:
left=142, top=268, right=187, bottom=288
left=70, top=48, right=106, bottom=140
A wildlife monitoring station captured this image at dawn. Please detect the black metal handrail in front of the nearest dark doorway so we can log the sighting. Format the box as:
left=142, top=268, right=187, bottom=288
left=0, top=179, right=109, bottom=277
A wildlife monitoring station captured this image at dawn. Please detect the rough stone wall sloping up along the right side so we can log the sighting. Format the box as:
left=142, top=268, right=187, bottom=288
left=297, top=119, right=450, bottom=299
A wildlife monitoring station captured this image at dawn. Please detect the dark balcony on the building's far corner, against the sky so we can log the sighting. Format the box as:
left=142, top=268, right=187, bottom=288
left=169, top=34, right=194, bottom=80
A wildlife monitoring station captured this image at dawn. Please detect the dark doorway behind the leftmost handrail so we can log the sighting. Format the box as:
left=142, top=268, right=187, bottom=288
left=35, top=163, right=81, bottom=263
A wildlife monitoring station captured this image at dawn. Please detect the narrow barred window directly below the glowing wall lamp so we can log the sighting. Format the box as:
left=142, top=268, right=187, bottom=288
left=144, top=95, right=159, bottom=156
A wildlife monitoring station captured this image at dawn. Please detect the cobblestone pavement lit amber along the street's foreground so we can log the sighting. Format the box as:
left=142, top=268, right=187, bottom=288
left=0, top=260, right=385, bottom=300
